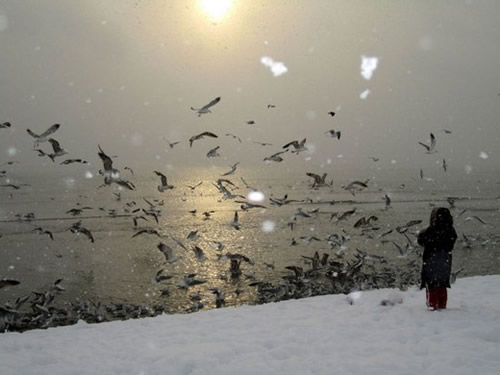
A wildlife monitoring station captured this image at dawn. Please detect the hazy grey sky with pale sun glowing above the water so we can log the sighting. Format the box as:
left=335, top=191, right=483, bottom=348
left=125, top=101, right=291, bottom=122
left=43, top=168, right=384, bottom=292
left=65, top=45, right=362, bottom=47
left=0, top=0, right=500, bottom=179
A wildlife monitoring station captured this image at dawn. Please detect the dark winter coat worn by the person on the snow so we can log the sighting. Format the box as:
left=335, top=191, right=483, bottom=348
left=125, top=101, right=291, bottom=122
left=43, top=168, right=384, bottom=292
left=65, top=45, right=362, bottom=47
left=418, top=223, right=457, bottom=288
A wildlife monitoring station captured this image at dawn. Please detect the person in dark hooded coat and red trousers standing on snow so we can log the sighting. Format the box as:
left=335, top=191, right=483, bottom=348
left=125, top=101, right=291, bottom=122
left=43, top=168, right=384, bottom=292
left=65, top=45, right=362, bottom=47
left=417, top=207, right=457, bottom=310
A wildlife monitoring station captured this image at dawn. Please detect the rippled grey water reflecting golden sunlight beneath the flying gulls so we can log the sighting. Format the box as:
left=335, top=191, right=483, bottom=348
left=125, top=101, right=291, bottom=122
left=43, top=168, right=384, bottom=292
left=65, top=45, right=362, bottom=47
left=0, top=169, right=500, bottom=312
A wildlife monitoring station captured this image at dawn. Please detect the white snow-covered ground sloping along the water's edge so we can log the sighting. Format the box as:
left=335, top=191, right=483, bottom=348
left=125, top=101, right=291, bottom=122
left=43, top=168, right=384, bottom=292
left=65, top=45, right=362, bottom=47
left=0, top=275, right=500, bottom=375
